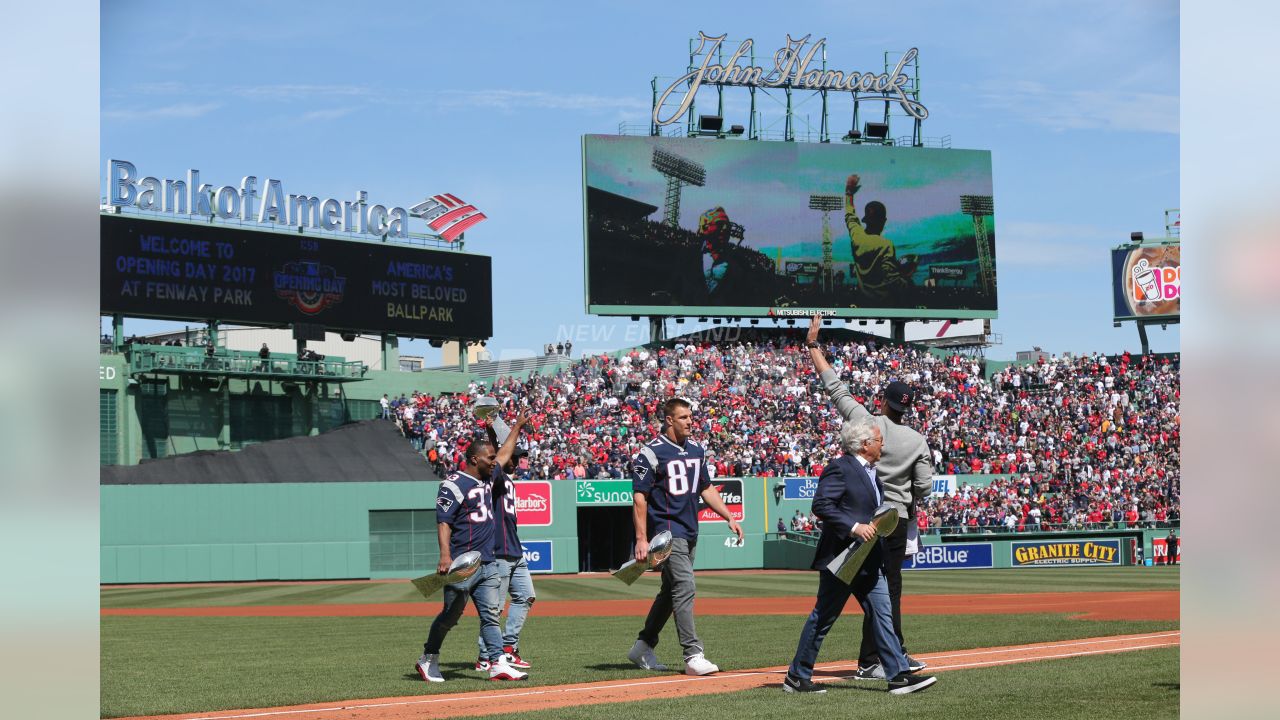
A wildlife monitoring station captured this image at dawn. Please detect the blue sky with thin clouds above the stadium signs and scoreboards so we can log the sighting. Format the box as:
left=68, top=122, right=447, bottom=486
left=100, top=0, right=1179, bottom=363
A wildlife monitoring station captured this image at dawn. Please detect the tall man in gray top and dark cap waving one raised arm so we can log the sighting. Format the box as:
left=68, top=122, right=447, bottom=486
left=805, top=315, right=933, bottom=680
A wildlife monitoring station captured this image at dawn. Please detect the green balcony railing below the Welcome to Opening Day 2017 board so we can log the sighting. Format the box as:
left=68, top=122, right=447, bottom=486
left=127, top=345, right=369, bottom=382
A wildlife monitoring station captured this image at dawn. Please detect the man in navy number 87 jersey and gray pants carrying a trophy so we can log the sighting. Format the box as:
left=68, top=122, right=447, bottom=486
left=627, top=397, right=742, bottom=675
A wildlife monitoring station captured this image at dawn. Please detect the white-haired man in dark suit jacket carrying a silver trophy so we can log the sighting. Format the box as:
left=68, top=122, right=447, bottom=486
left=782, top=420, right=937, bottom=694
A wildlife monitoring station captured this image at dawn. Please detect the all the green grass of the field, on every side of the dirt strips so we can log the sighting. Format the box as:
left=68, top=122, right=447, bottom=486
left=101, top=568, right=1178, bottom=719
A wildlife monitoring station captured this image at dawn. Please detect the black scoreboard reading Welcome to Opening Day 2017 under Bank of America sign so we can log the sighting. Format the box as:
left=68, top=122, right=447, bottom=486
left=101, top=215, right=493, bottom=340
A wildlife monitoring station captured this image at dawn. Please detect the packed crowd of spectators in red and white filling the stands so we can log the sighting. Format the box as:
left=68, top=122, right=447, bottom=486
left=390, top=340, right=1180, bottom=532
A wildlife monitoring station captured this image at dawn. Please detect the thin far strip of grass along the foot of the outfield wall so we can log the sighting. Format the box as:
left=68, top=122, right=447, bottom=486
left=100, top=566, right=1180, bottom=607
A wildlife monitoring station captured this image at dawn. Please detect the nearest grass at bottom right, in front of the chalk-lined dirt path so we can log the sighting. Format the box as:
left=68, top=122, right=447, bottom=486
left=463, top=648, right=1180, bottom=720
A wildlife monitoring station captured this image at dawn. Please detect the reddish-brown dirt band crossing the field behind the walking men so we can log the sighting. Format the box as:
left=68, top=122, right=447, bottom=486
left=101, top=591, right=1179, bottom=620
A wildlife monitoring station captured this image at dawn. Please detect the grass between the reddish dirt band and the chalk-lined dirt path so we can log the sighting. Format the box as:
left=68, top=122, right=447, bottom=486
left=101, top=605, right=1178, bottom=716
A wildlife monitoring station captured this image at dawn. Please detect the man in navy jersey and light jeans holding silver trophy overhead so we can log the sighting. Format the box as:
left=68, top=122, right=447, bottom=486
left=476, top=414, right=535, bottom=670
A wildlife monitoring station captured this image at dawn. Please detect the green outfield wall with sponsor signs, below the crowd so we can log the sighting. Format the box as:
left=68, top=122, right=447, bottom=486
left=100, top=478, right=1167, bottom=583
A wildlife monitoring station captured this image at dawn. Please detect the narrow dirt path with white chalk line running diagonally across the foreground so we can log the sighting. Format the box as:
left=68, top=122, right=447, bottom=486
left=115, top=630, right=1181, bottom=720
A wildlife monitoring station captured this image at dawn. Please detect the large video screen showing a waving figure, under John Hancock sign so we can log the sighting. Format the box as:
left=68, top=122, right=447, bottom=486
left=582, top=135, right=997, bottom=319
